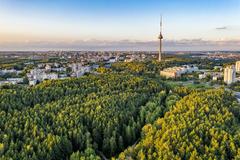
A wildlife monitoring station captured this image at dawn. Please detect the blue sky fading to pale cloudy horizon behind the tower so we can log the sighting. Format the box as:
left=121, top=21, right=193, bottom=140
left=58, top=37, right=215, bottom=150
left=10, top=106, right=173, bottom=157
left=0, top=0, right=240, bottom=50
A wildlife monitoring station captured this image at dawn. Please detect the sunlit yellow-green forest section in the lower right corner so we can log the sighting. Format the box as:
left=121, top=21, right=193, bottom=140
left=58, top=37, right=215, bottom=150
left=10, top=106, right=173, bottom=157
left=119, top=89, right=240, bottom=160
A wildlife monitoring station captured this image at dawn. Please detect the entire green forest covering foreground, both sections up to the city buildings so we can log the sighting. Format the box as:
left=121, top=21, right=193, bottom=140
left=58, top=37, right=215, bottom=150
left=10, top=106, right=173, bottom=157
left=0, top=58, right=240, bottom=160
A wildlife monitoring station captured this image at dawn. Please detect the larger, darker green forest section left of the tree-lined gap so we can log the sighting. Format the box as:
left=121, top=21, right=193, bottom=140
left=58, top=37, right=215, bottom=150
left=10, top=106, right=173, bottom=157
left=0, top=74, right=180, bottom=160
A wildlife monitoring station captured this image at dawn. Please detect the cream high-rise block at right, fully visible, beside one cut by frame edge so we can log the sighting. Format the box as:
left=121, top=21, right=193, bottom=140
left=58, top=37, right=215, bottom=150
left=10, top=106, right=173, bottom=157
left=224, top=65, right=236, bottom=84
